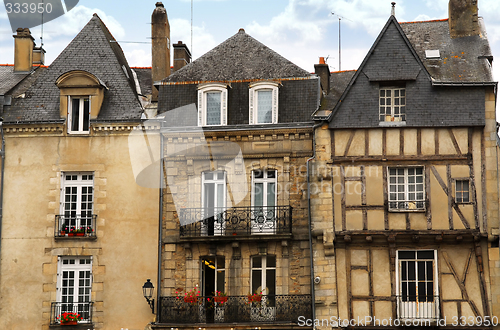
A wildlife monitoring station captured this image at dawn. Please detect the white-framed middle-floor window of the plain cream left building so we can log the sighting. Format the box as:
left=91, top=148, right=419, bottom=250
left=60, top=172, right=94, bottom=233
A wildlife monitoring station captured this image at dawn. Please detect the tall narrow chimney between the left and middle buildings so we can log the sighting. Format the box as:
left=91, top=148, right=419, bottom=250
left=151, top=2, right=170, bottom=102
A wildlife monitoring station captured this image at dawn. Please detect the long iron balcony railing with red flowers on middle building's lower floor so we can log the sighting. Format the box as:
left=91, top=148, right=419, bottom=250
left=158, top=295, right=312, bottom=324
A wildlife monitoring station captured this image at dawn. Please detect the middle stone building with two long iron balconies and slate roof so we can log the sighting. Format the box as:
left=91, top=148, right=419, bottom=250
left=154, top=29, right=320, bottom=329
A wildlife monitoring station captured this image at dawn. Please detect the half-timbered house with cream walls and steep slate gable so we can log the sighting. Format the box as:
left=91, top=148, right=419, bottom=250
left=311, top=1, right=499, bottom=329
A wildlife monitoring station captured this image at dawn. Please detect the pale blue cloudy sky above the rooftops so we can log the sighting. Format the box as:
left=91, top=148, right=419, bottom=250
left=0, top=0, right=500, bottom=80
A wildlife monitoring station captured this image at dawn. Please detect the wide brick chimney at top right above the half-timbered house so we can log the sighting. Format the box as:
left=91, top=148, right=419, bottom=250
left=448, top=0, right=479, bottom=38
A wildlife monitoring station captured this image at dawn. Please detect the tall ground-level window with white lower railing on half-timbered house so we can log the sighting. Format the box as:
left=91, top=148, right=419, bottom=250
left=396, top=250, right=439, bottom=319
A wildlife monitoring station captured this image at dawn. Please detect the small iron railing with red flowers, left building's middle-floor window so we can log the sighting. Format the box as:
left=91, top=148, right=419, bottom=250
left=54, top=214, right=97, bottom=238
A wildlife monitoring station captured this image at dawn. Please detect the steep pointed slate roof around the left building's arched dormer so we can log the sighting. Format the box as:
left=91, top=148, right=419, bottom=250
left=3, top=14, right=142, bottom=122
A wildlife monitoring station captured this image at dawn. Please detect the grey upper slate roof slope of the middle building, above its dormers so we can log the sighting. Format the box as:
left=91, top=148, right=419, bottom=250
left=163, top=29, right=311, bottom=82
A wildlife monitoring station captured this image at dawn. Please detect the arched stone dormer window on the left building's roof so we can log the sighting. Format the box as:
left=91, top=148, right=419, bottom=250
left=56, top=70, right=107, bottom=134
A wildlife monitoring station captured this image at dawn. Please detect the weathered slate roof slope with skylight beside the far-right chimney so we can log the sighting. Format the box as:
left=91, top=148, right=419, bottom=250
left=400, top=18, right=493, bottom=83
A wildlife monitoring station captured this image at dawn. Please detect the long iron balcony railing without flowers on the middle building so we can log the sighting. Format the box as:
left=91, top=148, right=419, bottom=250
left=179, top=206, right=292, bottom=237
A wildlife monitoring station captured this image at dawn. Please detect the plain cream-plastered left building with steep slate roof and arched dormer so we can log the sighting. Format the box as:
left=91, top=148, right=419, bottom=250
left=0, top=14, right=159, bottom=329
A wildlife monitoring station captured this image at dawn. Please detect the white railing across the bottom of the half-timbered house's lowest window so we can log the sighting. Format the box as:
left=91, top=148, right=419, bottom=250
left=396, top=295, right=439, bottom=321
